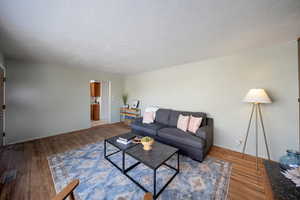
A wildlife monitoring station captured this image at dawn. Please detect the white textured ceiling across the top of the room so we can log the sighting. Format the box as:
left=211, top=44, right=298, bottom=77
left=0, top=0, right=300, bottom=74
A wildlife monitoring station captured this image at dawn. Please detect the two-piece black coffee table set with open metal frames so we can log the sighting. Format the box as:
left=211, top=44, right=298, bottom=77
left=104, top=133, right=179, bottom=199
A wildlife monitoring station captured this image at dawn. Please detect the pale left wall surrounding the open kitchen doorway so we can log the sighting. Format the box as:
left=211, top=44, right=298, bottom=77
left=6, top=60, right=124, bottom=143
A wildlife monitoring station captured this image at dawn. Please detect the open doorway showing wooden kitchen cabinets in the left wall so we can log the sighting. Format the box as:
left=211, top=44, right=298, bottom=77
left=90, top=80, right=111, bottom=126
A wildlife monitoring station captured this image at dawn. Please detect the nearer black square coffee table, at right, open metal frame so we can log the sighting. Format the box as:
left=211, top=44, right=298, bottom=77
left=125, top=141, right=179, bottom=199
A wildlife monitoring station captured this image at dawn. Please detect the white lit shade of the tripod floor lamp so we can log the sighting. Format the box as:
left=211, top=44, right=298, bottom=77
left=244, top=89, right=272, bottom=103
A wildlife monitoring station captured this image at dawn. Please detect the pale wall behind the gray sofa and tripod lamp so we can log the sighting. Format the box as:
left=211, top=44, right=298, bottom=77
left=125, top=41, right=298, bottom=160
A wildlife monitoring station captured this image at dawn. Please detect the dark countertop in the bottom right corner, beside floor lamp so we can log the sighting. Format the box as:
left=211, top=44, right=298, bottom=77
left=264, top=160, right=300, bottom=200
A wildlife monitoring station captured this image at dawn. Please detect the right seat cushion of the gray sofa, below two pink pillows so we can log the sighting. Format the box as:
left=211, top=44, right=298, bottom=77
left=158, top=128, right=205, bottom=149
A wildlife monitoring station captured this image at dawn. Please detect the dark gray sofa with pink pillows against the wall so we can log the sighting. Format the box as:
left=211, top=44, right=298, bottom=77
left=131, top=109, right=213, bottom=162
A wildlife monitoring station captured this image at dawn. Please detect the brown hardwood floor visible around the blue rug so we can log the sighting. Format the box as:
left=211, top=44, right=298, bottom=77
left=0, top=124, right=268, bottom=200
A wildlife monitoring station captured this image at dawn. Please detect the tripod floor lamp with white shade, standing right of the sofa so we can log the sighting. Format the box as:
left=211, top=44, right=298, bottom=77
left=243, top=89, right=272, bottom=170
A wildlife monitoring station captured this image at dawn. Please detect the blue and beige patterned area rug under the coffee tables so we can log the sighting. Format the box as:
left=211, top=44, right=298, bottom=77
left=48, top=142, right=231, bottom=200
